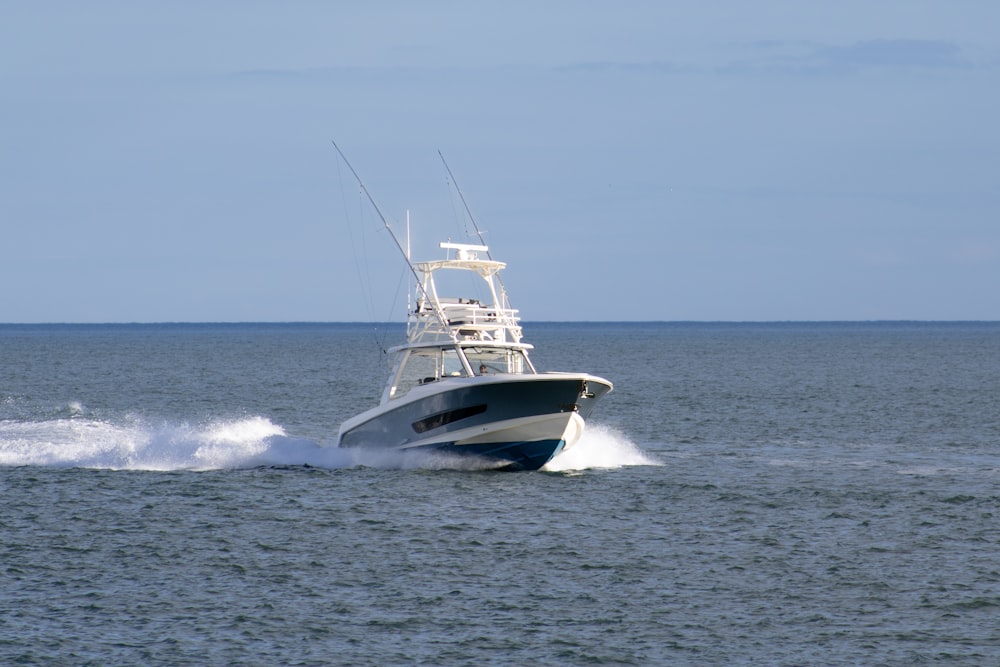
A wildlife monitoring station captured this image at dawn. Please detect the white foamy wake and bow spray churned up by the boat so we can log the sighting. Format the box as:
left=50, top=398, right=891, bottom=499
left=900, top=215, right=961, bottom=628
left=0, top=416, right=658, bottom=472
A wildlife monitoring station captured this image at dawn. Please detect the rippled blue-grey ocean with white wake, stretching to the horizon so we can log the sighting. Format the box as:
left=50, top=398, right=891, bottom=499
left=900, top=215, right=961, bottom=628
left=0, top=323, right=1000, bottom=666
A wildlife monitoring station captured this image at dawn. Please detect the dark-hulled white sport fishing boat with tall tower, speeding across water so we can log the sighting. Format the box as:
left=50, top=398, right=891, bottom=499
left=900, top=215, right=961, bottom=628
left=334, top=143, right=613, bottom=470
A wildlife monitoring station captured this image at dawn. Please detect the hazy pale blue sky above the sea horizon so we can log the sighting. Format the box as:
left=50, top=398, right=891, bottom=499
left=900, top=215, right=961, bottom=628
left=0, top=0, right=1000, bottom=322
